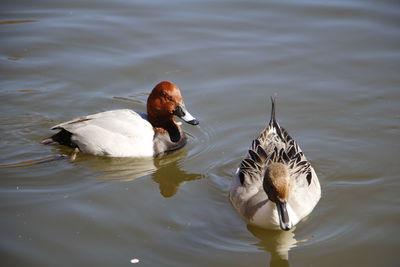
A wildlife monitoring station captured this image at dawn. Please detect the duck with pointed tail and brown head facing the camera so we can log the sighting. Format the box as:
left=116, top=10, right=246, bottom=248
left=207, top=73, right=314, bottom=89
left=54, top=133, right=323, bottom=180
left=229, top=97, right=321, bottom=231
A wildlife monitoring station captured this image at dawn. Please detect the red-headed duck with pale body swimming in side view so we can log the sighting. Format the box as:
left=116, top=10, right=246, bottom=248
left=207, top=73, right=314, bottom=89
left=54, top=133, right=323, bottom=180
left=42, top=81, right=199, bottom=158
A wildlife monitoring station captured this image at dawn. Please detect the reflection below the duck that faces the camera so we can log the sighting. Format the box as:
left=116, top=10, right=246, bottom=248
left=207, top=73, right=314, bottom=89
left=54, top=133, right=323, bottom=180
left=247, top=225, right=297, bottom=267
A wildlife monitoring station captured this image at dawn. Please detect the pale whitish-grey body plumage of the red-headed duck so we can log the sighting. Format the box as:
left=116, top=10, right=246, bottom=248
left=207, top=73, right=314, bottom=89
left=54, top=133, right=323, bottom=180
left=52, top=109, right=154, bottom=157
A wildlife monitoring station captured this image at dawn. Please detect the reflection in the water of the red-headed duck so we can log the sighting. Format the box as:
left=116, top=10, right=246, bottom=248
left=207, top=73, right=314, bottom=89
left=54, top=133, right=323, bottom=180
left=74, top=150, right=201, bottom=198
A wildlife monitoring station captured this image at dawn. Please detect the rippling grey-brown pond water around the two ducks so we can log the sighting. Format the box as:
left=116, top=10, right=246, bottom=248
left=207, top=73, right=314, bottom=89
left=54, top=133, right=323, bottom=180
left=0, top=0, right=400, bottom=266
